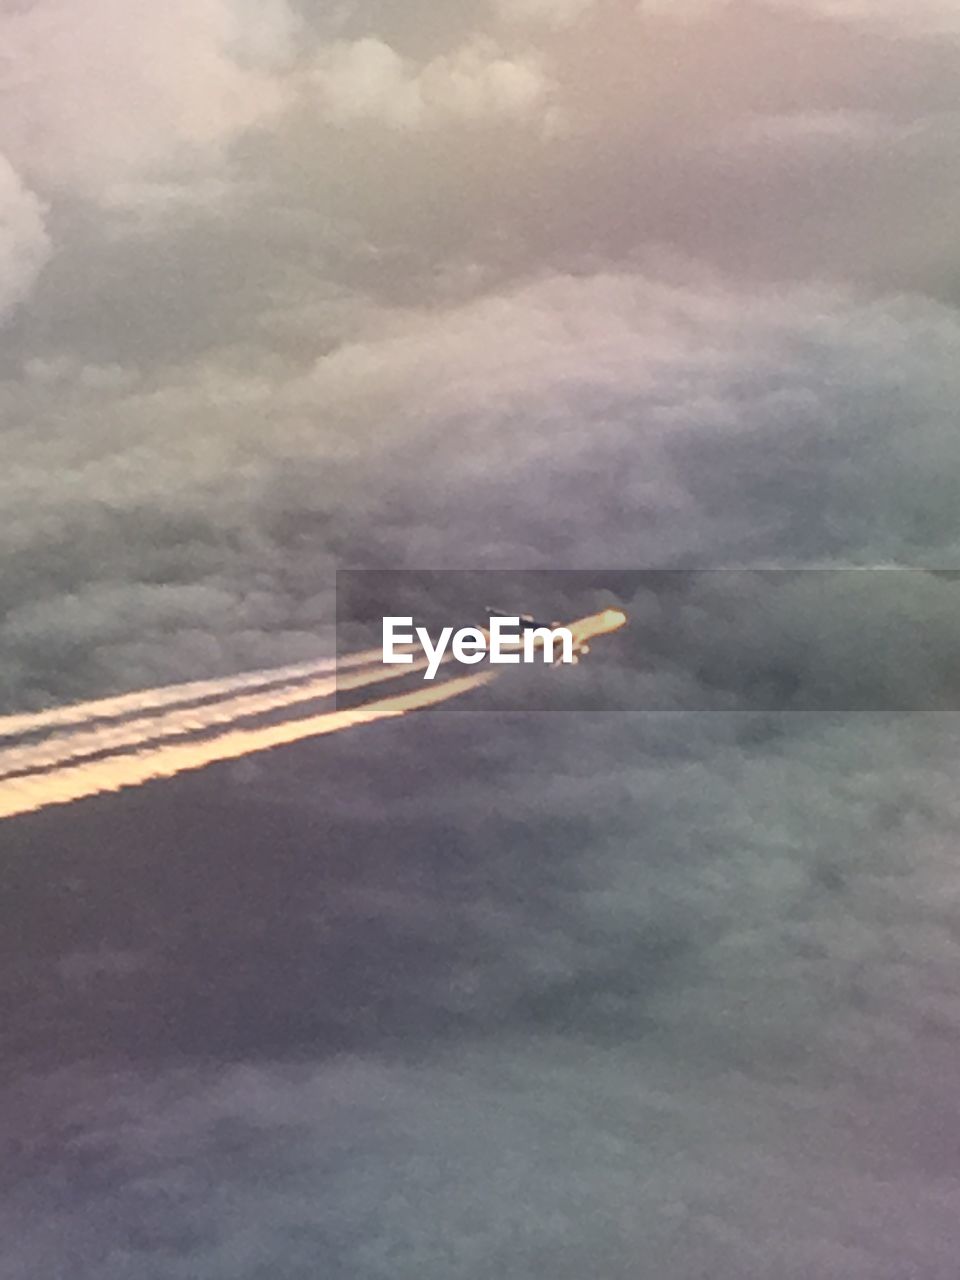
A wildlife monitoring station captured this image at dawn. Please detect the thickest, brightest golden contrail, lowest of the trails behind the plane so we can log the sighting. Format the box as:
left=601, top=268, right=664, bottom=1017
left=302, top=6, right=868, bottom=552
left=0, top=668, right=495, bottom=818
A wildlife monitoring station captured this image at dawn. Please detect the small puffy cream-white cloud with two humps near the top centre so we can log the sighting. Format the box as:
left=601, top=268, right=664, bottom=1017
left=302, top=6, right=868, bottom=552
left=314, top=37, right=552, bottom=131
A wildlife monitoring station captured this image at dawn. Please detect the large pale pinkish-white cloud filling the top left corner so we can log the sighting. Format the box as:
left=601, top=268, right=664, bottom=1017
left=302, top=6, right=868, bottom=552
left=0, top=0, right=291, bottom=202
